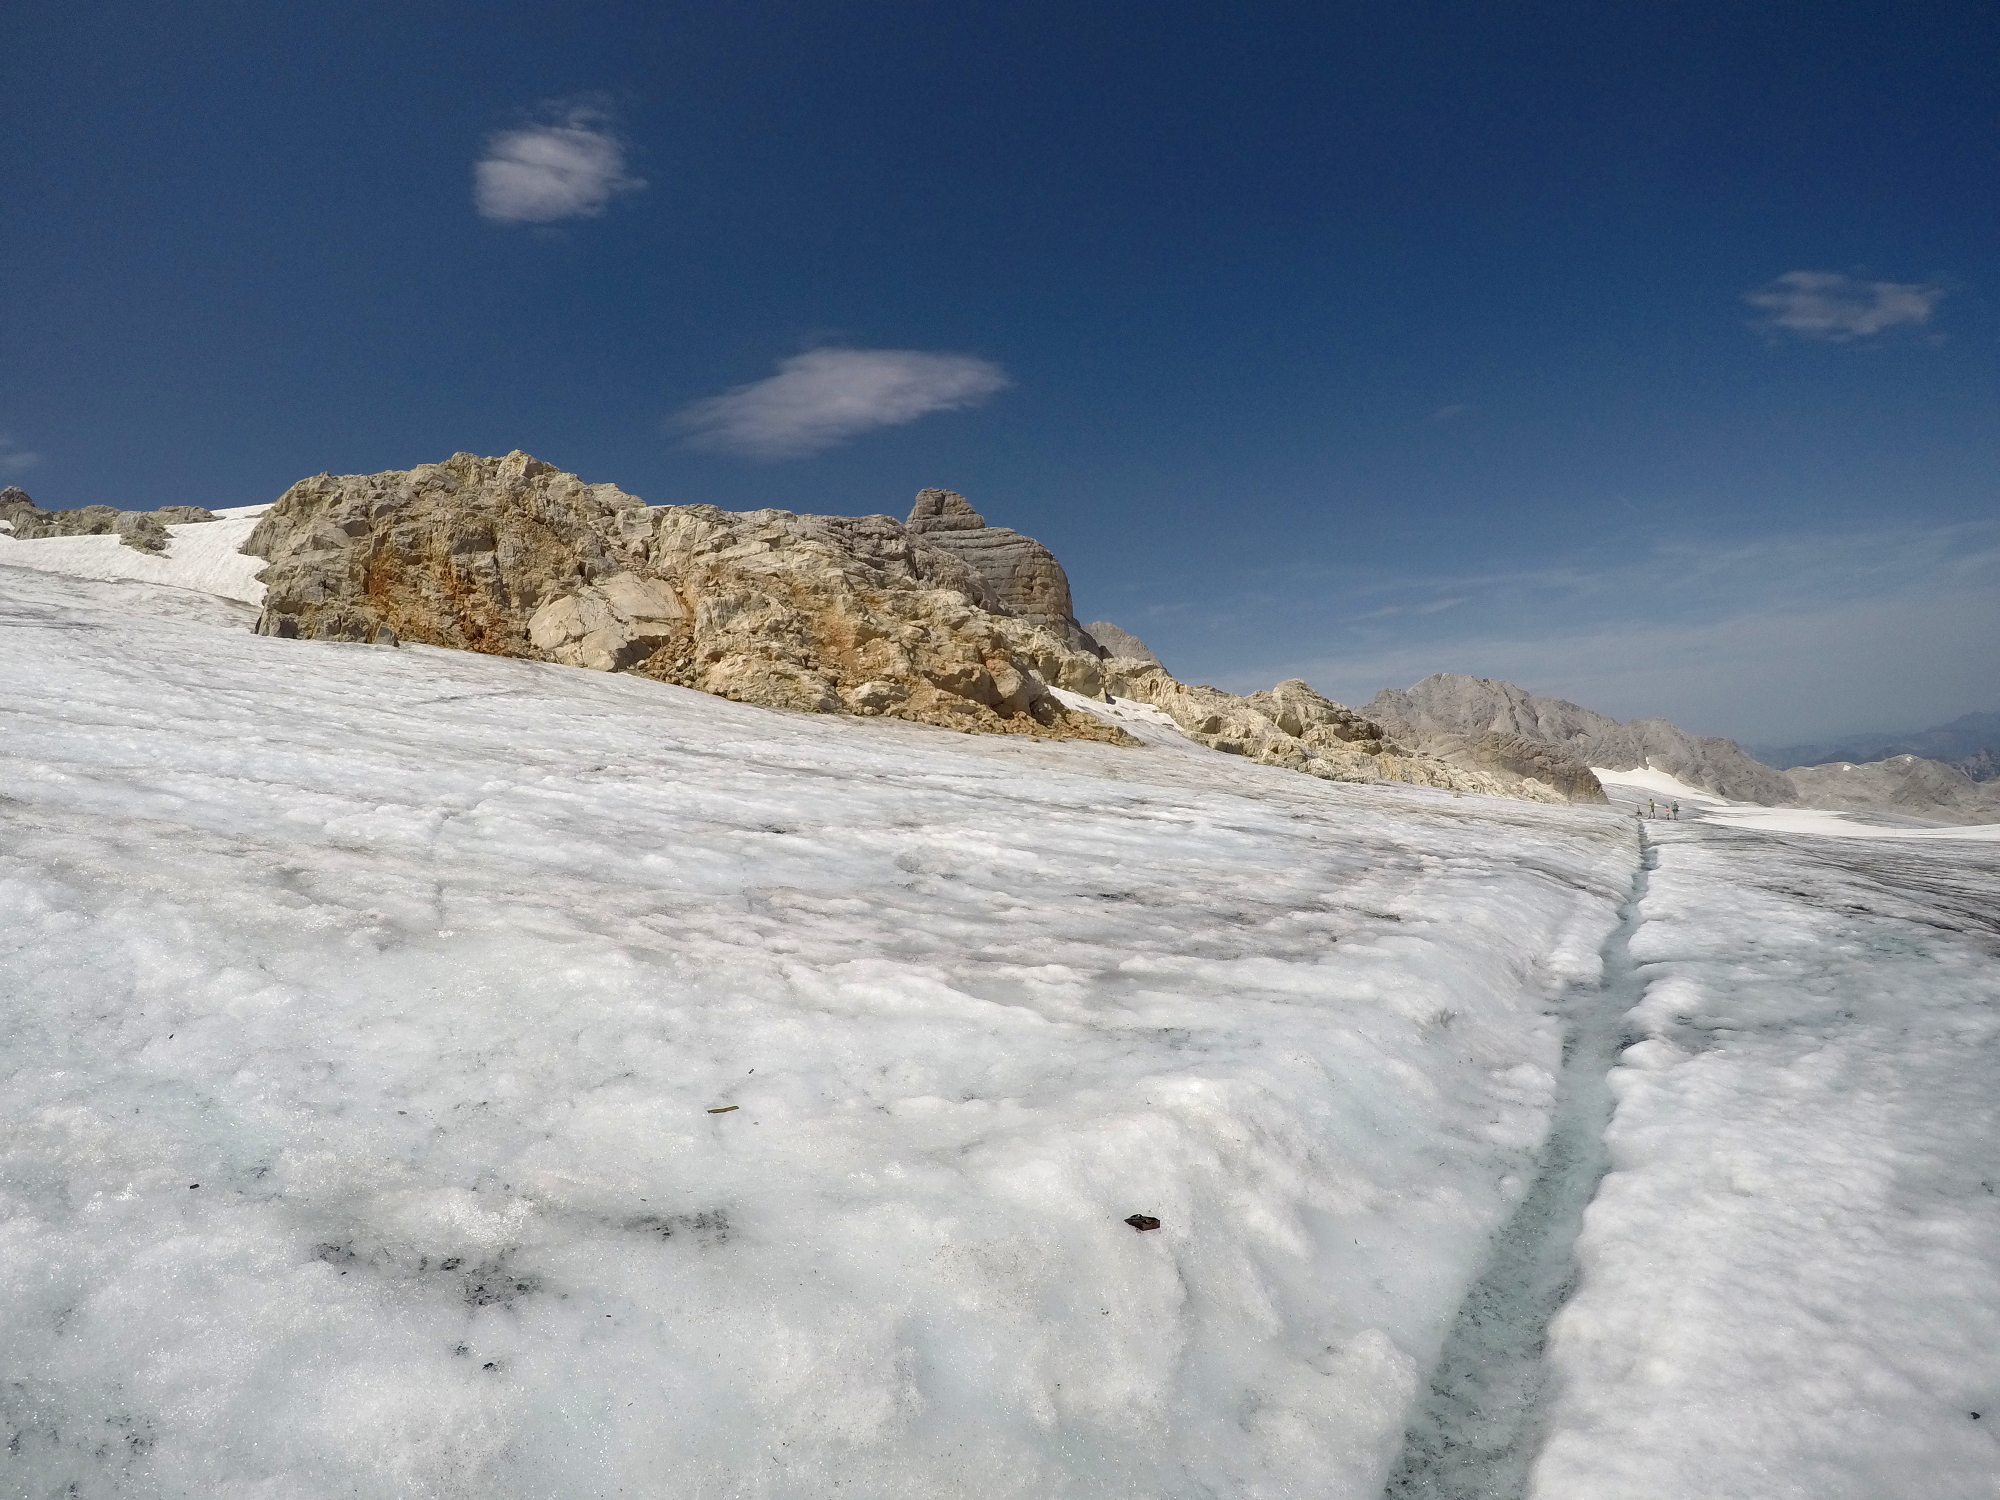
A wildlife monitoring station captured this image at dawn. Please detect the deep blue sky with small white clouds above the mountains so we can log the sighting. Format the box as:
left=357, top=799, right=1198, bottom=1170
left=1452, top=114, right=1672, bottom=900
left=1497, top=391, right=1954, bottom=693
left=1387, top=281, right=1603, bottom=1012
left=0, top=0, right=2000, bottom=740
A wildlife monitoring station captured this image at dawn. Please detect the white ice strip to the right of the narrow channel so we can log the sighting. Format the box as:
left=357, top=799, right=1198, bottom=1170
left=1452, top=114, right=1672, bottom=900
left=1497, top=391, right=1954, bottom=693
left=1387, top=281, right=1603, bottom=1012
left=1532, top=822, right=2000, bottom=1500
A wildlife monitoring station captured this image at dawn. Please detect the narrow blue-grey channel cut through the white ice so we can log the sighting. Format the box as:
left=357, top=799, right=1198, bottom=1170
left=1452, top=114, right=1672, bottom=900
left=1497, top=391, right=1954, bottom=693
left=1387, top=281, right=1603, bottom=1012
left=1384, top=828, right=1658, bottom=1500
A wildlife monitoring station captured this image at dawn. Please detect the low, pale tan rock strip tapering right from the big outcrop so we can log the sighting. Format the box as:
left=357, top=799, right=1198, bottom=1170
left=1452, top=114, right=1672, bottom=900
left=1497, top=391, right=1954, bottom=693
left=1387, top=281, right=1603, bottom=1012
left=1104, top=658, right=1604, bottom=802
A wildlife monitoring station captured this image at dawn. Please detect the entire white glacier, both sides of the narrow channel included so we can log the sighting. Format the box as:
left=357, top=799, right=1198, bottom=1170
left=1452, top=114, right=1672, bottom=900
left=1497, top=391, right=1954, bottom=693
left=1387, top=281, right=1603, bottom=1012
left=0, top=556, right=2000, bottom=1500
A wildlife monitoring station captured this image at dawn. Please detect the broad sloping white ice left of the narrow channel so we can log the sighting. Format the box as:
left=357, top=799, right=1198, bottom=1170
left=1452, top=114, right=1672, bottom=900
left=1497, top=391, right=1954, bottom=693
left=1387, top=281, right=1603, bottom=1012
left=0, top=568, right=1634, bottom=1500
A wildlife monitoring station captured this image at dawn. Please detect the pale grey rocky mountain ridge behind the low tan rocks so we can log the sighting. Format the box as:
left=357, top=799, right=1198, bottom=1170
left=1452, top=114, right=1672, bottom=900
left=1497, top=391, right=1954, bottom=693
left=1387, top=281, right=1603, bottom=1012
left=1368, top=672, right=1796, bottom=806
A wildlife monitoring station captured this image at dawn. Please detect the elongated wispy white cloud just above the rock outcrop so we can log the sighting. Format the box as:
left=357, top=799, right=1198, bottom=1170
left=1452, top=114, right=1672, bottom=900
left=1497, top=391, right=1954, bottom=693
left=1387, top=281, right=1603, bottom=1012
left=674, top=348, right=1008, bottom=458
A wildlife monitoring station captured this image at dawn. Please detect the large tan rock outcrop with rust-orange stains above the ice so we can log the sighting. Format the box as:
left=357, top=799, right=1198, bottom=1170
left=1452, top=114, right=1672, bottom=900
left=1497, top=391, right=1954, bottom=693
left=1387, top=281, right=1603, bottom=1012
left=244, top=452, right=1128, bottom=742
